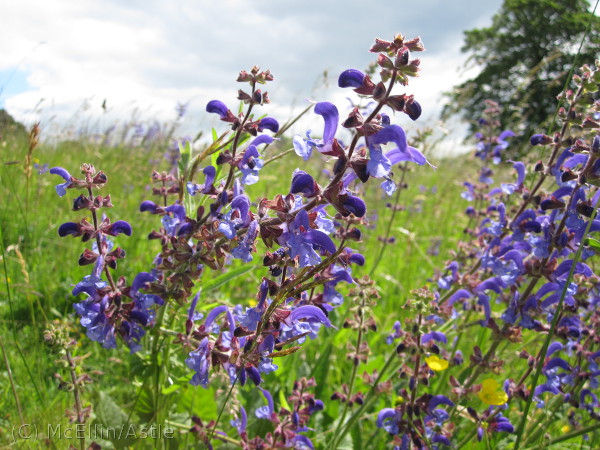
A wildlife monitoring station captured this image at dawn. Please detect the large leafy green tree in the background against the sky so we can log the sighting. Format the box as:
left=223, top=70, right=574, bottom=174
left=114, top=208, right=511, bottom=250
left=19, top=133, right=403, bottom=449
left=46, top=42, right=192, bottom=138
left=443, top=0, right=600, bottom=153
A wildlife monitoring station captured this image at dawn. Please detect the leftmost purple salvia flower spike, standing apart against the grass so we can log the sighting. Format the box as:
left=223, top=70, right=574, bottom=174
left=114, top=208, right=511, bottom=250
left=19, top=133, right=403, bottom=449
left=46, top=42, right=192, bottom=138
left=50, top=164, right=164, bottom=353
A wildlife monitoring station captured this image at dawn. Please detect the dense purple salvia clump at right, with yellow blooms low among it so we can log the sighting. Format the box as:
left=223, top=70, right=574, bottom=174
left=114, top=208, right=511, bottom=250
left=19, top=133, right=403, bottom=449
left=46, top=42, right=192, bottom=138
left=370, top=66, right=600, bottom=448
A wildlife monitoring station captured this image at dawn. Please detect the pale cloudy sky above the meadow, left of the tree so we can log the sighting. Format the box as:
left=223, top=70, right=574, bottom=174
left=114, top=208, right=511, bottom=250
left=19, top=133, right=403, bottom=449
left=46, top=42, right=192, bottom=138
left=0, top=0, right=501, bottom=153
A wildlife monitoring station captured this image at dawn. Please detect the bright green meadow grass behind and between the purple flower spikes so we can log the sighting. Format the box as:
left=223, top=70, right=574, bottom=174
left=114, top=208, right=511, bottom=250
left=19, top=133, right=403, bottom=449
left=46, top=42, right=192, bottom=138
left=0, top=124, right=568, bottom=448
